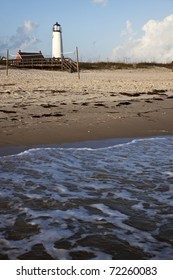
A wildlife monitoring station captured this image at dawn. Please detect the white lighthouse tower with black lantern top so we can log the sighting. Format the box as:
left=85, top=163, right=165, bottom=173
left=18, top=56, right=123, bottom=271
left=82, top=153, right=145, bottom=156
left=52, top=22, right=63, bottom=58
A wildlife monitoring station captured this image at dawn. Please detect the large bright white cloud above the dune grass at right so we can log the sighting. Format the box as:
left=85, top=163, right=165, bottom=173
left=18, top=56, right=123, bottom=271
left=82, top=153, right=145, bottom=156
left=112, top=14, right=173, bottom=63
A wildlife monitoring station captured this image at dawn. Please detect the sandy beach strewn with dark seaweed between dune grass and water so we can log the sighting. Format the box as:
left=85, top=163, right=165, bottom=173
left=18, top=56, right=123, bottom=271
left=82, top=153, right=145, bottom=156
left=0, top=65, right=173, bottom=151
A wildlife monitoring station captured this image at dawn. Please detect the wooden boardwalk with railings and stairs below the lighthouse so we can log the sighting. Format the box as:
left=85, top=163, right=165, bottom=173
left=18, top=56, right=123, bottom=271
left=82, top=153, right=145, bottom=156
left=8, top=58, right=77, bottom=73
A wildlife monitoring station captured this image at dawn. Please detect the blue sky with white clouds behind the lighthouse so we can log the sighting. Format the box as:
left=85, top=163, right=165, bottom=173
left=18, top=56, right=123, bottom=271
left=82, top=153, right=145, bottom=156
left=0, top=0, right=173, bottom=62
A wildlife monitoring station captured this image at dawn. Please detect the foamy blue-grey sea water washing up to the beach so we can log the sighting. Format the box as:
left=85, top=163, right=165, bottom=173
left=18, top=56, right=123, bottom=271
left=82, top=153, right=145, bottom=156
left=0, top=137, right=173, bottom=260
